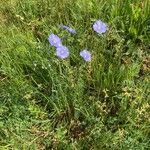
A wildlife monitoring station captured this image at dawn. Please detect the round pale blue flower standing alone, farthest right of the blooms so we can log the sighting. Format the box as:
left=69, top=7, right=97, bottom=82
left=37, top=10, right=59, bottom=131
left=93, top=20, right=108, bottom=34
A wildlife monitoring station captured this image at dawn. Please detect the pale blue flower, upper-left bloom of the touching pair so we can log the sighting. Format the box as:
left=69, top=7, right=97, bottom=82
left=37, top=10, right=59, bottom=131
left=48, top=34, right=62, bottom=47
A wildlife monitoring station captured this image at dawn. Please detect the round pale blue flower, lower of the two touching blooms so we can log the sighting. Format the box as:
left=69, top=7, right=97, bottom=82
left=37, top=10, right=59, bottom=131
left=56, top=45, right=69, bottom=59
